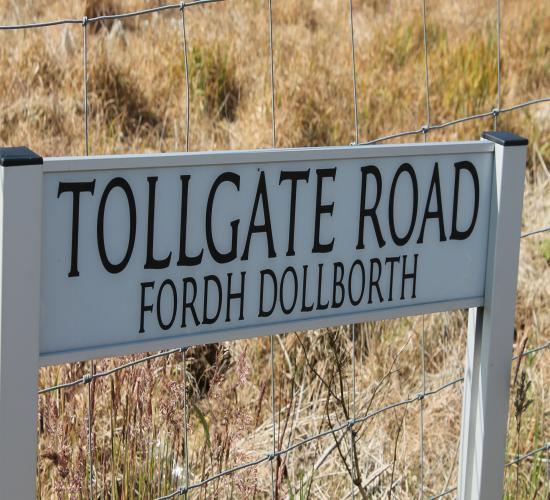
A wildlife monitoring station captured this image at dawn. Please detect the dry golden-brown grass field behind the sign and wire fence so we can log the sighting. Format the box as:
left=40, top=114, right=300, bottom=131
left=0, top=0, right=550, bottom=498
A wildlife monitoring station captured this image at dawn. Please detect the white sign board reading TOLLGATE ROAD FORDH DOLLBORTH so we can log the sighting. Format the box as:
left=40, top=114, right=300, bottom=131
left=40, top=141, right=494, bottom=363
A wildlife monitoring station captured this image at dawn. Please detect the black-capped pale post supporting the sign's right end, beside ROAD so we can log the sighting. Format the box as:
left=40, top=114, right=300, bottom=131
left=458, top=132, right=527, bottom=500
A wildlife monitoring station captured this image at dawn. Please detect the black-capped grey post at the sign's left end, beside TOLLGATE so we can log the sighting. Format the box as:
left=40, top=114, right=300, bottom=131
left=0, top=148, right=42, bottom=499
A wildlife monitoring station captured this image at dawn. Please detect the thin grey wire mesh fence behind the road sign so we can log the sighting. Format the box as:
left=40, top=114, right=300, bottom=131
left=0, top=0, right=550, bottom=500
